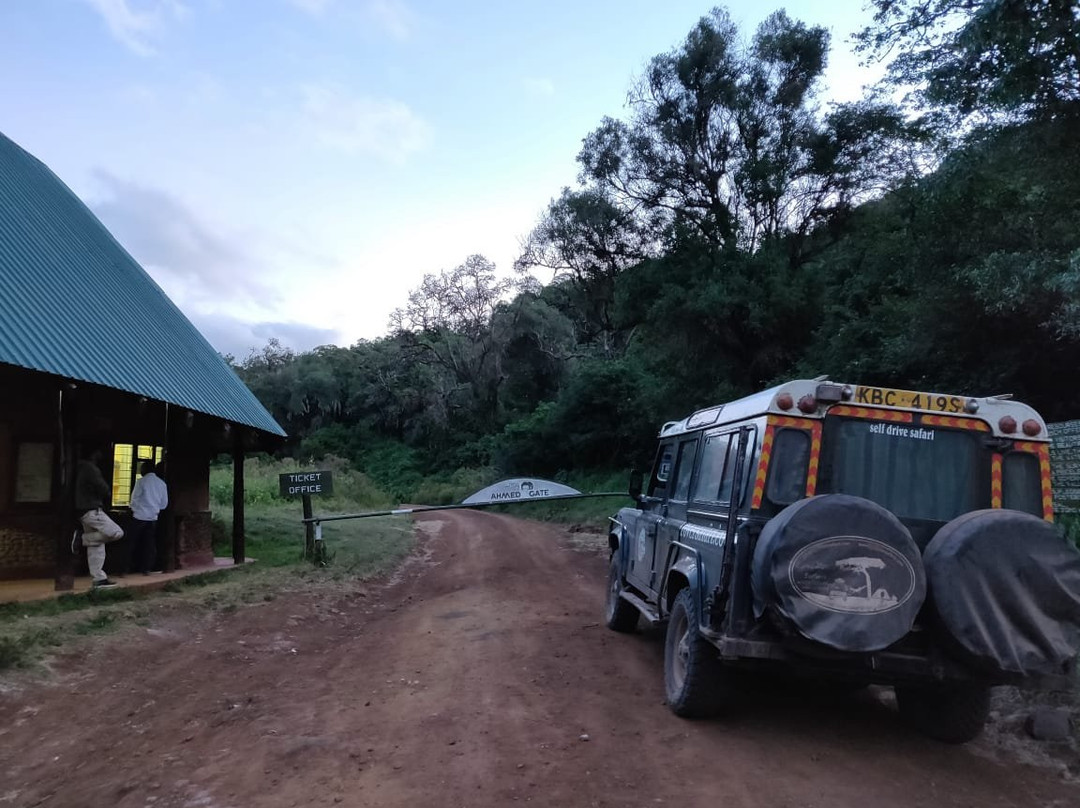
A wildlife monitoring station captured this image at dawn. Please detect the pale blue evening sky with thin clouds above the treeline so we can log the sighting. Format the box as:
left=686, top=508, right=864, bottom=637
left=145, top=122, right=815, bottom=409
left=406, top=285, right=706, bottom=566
left=0, top=0, right=874, bottom=359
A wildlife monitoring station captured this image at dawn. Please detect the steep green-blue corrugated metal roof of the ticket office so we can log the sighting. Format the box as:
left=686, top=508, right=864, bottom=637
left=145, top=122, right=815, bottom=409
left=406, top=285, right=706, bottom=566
left=0, top=134, right=285, bottom=435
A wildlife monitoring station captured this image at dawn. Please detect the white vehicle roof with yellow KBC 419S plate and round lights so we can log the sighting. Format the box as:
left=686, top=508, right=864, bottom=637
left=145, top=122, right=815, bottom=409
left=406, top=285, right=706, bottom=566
left=660, top=377, right=1050, bottom=443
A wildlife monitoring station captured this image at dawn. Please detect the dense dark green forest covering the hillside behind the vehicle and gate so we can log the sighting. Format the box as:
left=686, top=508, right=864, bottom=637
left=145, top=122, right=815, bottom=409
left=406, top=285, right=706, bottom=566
left=235, top=0, right=1080, bottom=498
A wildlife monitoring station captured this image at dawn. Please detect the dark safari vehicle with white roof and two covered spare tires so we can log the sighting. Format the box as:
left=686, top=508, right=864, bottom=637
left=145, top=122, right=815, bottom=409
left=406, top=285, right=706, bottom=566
left=606, top=379, right=1080, bottom=742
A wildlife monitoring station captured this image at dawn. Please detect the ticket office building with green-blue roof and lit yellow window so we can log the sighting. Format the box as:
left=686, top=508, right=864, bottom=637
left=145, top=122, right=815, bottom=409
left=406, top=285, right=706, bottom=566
left=0, top=134, right=285, bottom=589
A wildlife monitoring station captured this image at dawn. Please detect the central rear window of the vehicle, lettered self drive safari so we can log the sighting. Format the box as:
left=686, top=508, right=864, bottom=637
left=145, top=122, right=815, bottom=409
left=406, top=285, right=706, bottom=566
left=818, top=417, right=988, bottom=522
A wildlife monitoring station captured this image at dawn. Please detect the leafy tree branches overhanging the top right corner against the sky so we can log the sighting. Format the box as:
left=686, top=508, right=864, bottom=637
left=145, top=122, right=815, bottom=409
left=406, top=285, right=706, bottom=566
left=856, top=0, right=1080, bottom=120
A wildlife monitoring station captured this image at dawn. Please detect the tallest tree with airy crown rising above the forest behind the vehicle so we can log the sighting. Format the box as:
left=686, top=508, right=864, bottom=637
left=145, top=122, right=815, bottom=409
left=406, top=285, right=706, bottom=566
left=578, top=9, right=912, bottom=261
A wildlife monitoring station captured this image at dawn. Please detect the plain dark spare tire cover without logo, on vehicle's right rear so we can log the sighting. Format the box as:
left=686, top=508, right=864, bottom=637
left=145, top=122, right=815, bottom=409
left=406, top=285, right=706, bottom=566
left=923, top=510, right=1080, bottom=675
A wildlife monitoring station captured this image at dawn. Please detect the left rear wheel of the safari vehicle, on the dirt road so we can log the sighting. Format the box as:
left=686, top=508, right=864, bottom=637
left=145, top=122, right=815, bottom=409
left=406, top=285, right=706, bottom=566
left=664, top=588, right=727, bottom=718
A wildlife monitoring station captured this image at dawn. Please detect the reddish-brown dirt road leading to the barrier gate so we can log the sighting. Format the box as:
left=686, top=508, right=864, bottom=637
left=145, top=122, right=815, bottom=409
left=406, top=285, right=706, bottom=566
left=0, top=511, right=1080, bottom=808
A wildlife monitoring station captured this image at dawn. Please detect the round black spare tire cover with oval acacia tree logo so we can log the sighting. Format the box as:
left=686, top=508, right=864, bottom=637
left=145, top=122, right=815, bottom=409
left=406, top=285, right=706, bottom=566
left=752, top=494, right=927, bottom=651
